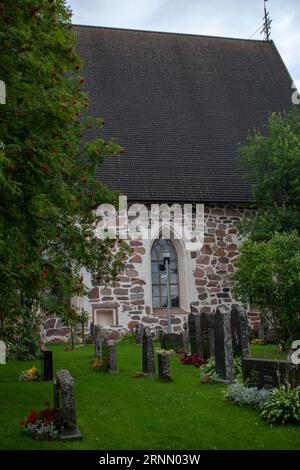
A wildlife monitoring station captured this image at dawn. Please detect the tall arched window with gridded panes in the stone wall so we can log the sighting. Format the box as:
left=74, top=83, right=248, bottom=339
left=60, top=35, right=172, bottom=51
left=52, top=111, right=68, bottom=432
left=151, top=238, right=179, bottom=308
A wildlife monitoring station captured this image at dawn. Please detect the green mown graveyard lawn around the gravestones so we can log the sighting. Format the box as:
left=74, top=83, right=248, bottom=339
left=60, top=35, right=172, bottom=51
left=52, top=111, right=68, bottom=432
left=0, top=344, right=300, bottom=450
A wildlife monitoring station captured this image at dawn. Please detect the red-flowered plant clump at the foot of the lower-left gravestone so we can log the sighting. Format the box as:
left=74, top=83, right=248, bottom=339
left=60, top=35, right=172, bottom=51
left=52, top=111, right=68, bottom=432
left=20, top=402, right=62, bottom=441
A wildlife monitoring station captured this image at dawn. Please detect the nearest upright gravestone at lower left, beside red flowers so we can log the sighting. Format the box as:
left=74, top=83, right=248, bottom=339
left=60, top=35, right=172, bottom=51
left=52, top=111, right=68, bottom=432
left=54, top=369, right=82, bottom=439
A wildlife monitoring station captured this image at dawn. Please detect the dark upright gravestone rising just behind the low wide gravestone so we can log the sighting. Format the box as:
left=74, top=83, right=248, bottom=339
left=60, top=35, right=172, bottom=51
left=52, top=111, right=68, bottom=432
left=231, top=305, right=250, bottom=357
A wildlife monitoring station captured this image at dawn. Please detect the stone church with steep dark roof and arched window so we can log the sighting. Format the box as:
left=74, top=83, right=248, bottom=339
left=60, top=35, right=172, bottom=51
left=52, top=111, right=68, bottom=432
left=45, top=26, right=292, bottom=341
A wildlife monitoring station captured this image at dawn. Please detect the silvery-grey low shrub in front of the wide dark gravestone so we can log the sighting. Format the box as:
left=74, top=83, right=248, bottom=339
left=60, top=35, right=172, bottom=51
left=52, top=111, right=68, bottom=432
left=224, top=383, right=271, bottom=408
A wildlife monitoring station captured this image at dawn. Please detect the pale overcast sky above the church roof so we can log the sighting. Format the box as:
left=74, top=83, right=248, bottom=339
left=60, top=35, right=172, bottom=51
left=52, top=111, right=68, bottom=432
left=67, top=0, right=300, bottom=89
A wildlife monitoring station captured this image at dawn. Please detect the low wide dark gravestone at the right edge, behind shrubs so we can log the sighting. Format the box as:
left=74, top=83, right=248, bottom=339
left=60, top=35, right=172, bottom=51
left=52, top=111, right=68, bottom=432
left=242, top=358, right=300, bottom=389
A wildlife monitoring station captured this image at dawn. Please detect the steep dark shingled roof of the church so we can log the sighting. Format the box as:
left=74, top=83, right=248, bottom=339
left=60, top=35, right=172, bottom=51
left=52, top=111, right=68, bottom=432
left=73, top=26, right=292, bottom=203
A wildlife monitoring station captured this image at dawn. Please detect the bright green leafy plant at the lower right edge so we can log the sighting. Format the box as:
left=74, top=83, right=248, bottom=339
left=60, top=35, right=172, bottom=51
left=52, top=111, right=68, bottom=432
left=261, top=384, right=300, bottom=424
